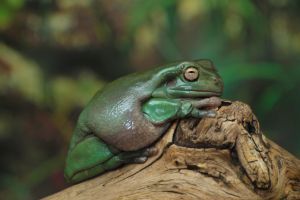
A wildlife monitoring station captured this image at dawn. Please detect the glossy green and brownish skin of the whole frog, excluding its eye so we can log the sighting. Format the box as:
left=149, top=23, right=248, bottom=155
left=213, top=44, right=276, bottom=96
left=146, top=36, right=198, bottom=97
left=65, top=60, right=223, bottom=183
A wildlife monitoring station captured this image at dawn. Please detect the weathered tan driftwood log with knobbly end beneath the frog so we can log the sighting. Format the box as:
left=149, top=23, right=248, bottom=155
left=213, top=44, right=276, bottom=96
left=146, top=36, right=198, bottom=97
left=45, top=101, right=300, bottom=200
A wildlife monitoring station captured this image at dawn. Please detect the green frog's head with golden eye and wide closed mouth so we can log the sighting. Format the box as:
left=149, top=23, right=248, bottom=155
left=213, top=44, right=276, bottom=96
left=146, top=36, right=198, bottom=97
left=153, top=60, right=223, bottom=98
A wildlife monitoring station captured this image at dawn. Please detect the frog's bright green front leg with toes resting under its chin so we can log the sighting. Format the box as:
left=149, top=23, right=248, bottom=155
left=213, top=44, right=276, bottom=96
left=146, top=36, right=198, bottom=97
left=142, top=97, right=221, bottom=124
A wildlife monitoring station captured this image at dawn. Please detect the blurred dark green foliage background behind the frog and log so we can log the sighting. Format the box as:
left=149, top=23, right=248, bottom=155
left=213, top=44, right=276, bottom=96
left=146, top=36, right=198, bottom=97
left=0, top=0, right=300, bottom=199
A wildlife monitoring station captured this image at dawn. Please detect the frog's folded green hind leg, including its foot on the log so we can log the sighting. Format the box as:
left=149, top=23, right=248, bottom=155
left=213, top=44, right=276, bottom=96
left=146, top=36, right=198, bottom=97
left=65, top=135, right=157, bottom=183
